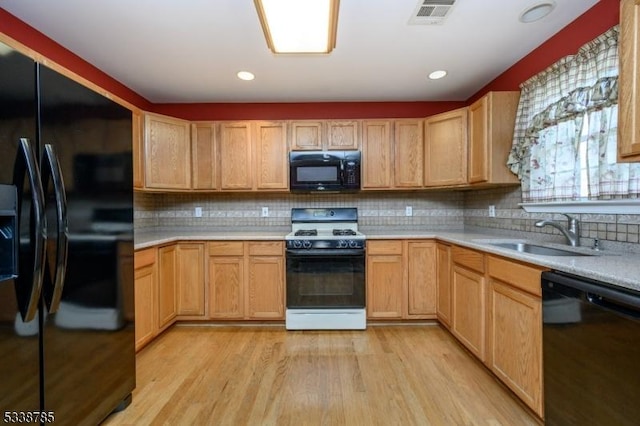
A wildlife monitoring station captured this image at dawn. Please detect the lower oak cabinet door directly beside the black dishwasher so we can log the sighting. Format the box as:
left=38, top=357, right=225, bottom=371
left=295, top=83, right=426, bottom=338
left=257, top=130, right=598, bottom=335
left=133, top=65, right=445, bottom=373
left=488, top=279, right=543, bottom=417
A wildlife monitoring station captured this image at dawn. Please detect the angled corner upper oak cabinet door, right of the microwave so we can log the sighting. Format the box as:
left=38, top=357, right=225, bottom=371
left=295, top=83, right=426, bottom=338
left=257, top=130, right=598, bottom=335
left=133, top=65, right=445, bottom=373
left=424, top=108, right=467, bottom=186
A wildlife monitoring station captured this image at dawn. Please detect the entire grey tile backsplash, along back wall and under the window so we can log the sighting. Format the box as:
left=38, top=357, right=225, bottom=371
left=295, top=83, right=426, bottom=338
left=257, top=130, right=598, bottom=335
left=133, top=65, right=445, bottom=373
left=135, top=187, right=640, bottom=251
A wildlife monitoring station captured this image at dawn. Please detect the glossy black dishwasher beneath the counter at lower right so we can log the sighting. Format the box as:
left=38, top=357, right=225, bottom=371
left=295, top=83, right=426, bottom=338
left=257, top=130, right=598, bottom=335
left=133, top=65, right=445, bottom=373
left=542, top=272, right=640, bottom=425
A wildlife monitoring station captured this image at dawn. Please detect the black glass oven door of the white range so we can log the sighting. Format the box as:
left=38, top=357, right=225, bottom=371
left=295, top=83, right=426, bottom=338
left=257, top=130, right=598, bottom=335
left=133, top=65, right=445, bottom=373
left=287, top=249, right=366, bottom=309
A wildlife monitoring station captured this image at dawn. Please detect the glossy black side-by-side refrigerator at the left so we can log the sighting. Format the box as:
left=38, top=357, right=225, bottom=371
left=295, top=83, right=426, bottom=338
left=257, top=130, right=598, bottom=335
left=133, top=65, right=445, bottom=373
left=0, top=43, right=135, bottom=425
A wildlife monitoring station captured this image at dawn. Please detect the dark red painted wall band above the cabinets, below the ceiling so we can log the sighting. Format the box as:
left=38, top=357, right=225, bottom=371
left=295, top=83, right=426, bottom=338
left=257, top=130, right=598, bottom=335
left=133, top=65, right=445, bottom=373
left=0, top=0, right=620, bottom=120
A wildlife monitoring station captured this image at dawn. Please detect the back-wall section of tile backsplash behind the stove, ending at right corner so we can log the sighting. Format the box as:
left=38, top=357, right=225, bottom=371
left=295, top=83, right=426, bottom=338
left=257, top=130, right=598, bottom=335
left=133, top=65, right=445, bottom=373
left=134, top=192, right=464, bottom=231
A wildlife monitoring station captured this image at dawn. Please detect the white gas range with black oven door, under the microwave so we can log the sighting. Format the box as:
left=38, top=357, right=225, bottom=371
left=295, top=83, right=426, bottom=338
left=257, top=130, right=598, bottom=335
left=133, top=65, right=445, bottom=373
left=285, top=208, right=366, bottom=330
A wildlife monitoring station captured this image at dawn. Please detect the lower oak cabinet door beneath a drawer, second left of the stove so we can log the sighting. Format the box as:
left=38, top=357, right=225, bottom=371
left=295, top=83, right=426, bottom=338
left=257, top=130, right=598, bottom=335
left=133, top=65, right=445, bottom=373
left=209, top=256, right=244, bottom=319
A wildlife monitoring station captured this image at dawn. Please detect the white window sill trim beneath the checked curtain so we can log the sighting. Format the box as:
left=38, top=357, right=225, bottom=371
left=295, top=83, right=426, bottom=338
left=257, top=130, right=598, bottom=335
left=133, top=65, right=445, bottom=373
left=518, top=199, right=640, bottom=214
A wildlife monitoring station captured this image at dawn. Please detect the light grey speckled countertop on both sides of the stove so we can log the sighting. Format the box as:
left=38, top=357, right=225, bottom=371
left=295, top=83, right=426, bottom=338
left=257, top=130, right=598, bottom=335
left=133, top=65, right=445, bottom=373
left=135, top=228, right=640, bottom=291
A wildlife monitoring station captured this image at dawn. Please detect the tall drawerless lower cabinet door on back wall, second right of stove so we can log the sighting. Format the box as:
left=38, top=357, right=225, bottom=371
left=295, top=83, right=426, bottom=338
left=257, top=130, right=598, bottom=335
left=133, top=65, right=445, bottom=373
left=407, top=241, right=437, bottom=318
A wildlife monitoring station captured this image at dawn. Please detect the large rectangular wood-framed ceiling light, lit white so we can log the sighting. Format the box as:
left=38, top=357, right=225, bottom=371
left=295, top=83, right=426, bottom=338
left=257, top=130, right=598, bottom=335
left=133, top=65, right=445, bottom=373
left=254, top=0, right=340, bottom=53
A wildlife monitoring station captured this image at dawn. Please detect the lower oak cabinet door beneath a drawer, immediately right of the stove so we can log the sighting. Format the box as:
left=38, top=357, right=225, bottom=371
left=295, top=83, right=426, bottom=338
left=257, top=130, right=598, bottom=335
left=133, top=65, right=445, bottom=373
left=367, top=255, right=404, bottom=319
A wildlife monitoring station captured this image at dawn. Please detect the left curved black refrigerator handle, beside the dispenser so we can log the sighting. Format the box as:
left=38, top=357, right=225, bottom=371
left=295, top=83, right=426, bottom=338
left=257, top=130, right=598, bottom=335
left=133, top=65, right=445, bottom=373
left=13, top=138, right=47, bottom=322
